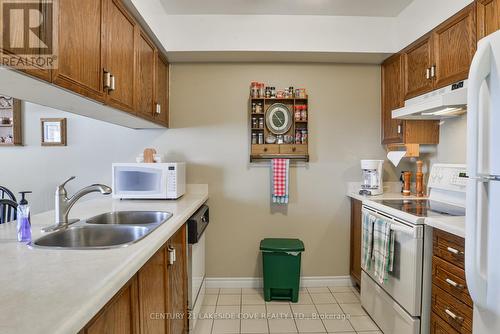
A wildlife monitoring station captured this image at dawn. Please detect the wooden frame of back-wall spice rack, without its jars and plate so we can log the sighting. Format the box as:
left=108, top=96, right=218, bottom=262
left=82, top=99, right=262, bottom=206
left=248, top=91, right=310, bottom=162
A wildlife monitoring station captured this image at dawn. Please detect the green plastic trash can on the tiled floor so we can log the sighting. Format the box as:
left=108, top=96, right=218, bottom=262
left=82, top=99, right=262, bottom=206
left=260, top=238, right=304, bottom=303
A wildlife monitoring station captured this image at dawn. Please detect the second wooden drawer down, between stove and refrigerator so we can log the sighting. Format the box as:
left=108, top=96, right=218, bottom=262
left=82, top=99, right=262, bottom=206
left=432, top=256, right=473, bottom=307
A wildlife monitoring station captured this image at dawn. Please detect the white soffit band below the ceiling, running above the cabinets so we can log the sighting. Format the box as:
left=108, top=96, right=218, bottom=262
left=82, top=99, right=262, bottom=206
left=128, top=0, right=473, bottom=61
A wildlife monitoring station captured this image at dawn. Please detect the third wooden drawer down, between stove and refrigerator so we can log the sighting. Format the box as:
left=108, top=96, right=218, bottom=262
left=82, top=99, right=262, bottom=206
left=432, top=284, right=472, bottom=334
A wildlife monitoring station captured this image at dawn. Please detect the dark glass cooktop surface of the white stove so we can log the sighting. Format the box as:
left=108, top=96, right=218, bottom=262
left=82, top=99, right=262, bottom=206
left=377, top=199, right=465, bottom=217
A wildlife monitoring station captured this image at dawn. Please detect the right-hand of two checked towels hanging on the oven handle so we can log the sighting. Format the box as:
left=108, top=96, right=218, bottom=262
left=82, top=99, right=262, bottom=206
left=373, top=219, right=394, bottom=284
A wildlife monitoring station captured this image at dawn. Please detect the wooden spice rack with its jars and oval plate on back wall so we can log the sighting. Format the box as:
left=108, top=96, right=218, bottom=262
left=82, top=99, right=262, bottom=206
left=248, top=82, right=310, bottom=162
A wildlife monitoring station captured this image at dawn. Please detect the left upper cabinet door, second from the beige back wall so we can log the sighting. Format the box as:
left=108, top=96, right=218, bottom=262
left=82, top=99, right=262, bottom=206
left=135, top=29, right=156, bottom=118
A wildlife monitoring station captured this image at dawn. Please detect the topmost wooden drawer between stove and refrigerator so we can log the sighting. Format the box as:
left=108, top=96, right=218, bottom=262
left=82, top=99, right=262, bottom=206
left=433, top=229, right=465, bottom=269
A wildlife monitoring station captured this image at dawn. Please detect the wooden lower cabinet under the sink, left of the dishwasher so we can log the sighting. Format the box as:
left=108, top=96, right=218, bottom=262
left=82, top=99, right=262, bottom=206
left=80, top=225, right=188, bottom=334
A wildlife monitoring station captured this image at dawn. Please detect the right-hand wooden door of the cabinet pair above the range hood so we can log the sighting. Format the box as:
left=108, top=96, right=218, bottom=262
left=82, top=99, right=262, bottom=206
left=432, top=4, right=476, bottom=89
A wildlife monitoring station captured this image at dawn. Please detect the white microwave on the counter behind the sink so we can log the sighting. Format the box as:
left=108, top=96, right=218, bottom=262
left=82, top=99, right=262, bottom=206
left=112, top=162, right=186, bottom=199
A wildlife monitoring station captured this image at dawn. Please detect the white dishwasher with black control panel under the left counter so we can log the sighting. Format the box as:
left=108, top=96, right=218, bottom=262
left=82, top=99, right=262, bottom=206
left=187, top=205, right=209, bottom=332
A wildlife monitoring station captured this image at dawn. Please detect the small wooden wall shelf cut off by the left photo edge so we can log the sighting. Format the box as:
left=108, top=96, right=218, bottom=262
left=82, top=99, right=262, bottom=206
left=0, top=95, right=23, bottom=146
